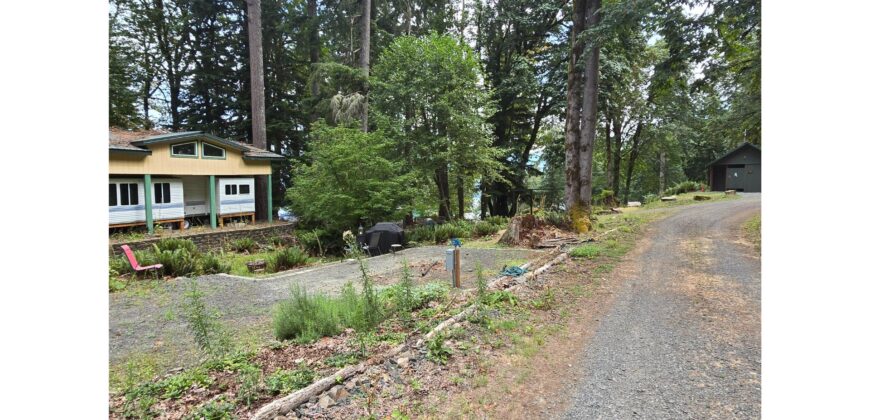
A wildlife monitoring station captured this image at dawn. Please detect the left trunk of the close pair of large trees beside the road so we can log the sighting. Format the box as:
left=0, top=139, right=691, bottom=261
left=565, top=0, right=586, bottom=209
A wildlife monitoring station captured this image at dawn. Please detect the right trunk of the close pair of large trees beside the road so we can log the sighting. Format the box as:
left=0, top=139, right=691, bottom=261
left=579, top=0, right=601, bottom=208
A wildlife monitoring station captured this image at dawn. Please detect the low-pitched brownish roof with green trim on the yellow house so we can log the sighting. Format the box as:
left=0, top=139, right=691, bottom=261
left=109, top=127, right=284, bottom=160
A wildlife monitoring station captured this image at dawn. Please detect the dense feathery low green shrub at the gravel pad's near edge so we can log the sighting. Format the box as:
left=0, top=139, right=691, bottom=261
left=273, top=284, right=341, bottom=342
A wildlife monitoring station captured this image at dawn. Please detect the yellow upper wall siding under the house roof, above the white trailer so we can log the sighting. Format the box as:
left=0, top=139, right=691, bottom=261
left=109, top=140, right=272, bottom=175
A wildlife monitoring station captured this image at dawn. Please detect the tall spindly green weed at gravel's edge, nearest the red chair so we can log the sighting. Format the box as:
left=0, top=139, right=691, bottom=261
left=182, top=280, right=232, bottom=358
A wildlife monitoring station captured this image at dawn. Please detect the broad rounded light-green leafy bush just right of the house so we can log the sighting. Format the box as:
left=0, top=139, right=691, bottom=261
left=287, top=124, right=416, bottom=230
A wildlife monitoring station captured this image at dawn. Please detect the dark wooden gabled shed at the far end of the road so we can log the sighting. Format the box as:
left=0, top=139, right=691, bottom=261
left=707, top=143, right=761, bottom=192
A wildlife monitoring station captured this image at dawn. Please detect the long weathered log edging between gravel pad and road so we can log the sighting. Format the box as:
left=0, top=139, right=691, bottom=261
left=251, top=252, right=568, bottom=420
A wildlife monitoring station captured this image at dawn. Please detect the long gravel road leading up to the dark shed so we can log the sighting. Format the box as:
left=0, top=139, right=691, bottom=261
left=564, top=194, right=761, bottom=419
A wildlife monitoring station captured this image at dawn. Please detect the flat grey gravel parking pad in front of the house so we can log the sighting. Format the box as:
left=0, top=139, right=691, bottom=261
left=109, top=246, right=540, bottom=365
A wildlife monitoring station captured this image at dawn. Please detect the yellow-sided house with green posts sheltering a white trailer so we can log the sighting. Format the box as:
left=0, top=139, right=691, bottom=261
left=109, top=128, right=284, bottom=232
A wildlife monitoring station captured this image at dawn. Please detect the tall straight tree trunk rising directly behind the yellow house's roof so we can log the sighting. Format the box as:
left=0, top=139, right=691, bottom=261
left=247, top=0, right=272, bottom=220
